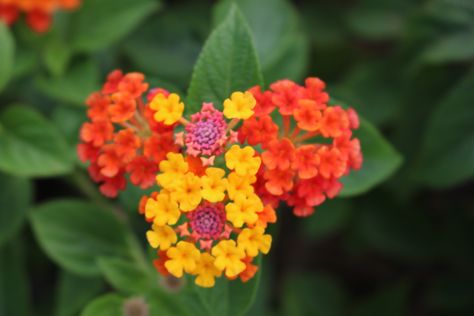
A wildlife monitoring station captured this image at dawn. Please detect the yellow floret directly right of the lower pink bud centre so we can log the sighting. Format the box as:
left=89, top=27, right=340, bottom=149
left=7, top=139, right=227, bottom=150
left=225, top=193, right=263, bottom=227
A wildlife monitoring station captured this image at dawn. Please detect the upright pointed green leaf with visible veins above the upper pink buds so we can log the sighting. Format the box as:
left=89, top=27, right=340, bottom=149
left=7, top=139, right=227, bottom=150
left=187, top=6, right=263, bottom=112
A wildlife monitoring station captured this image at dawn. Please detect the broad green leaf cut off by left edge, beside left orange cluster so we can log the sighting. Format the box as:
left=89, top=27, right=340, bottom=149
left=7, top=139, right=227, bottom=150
left=0, top=106, right=74, bottom=177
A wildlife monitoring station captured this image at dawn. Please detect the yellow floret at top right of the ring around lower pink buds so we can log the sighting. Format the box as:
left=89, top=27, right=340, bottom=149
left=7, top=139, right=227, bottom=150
left=225, top=145, right=261, bottom=176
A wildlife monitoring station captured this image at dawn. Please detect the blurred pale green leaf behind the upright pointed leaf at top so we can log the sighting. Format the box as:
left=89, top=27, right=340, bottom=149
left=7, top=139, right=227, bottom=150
left=214, top=0, right=309, bottom=83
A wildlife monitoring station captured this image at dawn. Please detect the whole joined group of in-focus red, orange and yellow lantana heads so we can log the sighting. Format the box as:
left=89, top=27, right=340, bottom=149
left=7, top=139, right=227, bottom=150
left=78, top=71, right=362, bottom=287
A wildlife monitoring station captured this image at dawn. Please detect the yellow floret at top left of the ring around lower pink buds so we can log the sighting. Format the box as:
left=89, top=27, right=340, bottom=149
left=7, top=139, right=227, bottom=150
left=156, top=153, right=189, bottom=190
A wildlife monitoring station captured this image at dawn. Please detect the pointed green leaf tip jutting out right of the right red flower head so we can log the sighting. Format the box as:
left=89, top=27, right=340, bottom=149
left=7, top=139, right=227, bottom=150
left=340, top=119, right=402, bottom=197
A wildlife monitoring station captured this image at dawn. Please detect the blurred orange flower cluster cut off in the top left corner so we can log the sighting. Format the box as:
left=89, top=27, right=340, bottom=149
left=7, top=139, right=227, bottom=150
left=0, top=0, right=81, bottom=33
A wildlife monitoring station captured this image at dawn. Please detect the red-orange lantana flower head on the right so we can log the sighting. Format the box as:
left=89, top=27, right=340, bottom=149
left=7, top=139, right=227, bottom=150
left=238, top=78, right=362, bottom=216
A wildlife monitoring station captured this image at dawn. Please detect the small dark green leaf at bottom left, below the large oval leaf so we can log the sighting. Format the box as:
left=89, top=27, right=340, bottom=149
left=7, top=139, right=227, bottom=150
left=54, top=270, right=104, bottom=316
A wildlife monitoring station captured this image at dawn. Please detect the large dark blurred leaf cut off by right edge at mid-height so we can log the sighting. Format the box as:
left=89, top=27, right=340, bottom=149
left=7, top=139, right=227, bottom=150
left=417, top=71, right=474, bottom=188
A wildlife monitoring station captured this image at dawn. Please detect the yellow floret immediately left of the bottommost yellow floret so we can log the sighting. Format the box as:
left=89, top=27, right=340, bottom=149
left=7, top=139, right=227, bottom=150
left=165, top=241, right=200, bottom=278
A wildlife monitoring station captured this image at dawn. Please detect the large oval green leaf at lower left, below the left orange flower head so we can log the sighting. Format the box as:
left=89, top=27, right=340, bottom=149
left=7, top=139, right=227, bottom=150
left=30, top=200, right=130, bottom=276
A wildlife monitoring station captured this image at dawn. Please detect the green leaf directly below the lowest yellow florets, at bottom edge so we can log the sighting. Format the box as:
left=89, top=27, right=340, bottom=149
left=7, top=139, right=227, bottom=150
left=195, top=257, right=262, bottom=316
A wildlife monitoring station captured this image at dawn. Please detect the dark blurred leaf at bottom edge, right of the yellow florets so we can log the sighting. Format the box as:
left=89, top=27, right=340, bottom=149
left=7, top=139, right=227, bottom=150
left=281, top=274, right=346, bottom=316
